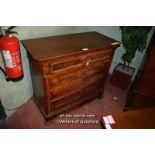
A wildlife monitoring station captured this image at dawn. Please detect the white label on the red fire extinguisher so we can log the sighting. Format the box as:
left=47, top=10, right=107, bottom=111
left=2, top=50, right=13, bottom=68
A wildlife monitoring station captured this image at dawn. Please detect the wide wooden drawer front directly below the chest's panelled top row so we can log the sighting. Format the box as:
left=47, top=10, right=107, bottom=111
left=48, top=64, right=105, bottom=92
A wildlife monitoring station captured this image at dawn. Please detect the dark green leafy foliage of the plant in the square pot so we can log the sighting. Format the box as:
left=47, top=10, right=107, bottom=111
left=120, top=26, right=151, bottom=65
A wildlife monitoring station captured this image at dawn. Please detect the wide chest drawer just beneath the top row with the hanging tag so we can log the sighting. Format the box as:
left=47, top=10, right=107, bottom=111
left=48, top=60, right=106, bottom=92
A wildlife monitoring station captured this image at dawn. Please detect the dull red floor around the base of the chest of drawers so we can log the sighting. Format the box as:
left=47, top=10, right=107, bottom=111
left=1, top=77, right=127, bottom=129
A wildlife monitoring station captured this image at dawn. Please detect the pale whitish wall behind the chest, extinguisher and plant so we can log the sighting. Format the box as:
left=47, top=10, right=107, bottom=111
left=0, top=26, right=153, bottom=116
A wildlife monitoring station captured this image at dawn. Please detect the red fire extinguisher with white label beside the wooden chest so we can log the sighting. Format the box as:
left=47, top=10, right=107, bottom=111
left=0, top=28, right=24, bottom=81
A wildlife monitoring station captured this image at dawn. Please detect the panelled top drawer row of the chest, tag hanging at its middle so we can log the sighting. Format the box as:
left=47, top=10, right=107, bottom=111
left=42, top=49, right=113, bottom=75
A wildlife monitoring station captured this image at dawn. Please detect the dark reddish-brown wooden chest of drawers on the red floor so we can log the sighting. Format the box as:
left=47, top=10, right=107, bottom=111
left=22, top=32, right=119, bottom=120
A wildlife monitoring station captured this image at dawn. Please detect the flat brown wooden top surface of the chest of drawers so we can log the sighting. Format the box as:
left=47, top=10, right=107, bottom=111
left=22, top=32, right=119, bottom=61
